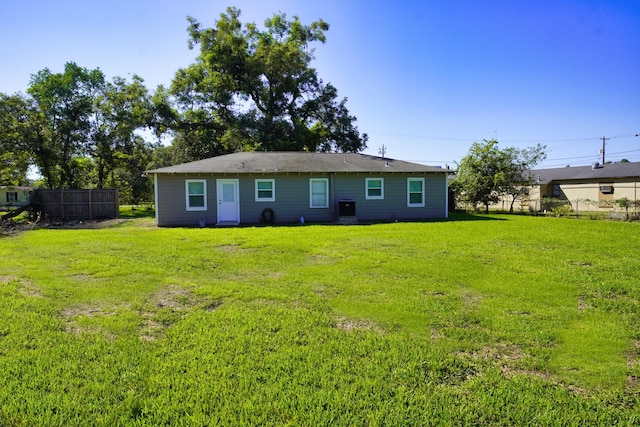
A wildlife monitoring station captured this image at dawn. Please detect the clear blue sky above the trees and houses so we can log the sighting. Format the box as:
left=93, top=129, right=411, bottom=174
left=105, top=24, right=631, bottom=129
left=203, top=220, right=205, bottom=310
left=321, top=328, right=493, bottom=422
left=0, top=0, right=640, bottom=167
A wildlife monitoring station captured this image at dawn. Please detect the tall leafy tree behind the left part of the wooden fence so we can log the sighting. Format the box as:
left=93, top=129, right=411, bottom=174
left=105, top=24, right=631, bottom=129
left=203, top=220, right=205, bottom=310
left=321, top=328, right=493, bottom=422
left=28, top=62, right=104, bottom=188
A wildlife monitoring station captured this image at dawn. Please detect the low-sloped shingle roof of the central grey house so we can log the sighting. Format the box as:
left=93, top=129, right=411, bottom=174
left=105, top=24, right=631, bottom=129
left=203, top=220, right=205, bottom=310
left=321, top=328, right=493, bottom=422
left=147, top=151, right=447, bottom=174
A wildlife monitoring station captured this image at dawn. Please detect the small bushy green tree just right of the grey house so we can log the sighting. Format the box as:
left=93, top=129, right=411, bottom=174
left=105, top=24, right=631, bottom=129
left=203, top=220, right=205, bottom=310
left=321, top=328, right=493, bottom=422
left=452, top=139, right=546, bottom=213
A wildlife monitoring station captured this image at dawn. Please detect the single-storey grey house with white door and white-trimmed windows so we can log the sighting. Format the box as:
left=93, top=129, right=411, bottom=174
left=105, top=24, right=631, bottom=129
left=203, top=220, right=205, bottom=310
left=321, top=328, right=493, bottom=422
left=147, top=152, right=448, bottom=226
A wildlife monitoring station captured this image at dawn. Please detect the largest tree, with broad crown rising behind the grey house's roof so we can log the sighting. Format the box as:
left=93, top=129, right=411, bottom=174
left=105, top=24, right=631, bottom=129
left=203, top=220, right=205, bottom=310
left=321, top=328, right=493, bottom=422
left=164, top=8, right=367, bottom=160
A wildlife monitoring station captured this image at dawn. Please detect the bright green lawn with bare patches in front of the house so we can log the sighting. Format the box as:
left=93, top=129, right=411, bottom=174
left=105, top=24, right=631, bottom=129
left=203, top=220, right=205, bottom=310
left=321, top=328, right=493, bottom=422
left=0, top=215, right=640, bottom=426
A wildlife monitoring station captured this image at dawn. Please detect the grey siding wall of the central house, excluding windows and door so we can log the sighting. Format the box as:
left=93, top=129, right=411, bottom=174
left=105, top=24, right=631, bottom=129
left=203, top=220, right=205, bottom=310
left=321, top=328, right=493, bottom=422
left=155, top=173, right=448, bottom=226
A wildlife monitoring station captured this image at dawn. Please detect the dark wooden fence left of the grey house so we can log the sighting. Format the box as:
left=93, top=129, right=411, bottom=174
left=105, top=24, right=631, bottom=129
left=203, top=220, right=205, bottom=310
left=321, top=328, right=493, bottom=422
left=37, top=189, right=120, bottom=220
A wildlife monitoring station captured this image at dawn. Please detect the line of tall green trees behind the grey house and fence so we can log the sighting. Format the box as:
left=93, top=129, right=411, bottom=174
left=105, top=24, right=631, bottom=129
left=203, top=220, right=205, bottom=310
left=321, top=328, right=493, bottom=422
left=0, top=8, right=367, bottom=203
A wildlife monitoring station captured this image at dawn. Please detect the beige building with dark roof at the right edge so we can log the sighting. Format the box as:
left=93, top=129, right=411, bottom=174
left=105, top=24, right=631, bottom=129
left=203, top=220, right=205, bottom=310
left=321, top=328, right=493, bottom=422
left=494, top=162, right=640, bottom=211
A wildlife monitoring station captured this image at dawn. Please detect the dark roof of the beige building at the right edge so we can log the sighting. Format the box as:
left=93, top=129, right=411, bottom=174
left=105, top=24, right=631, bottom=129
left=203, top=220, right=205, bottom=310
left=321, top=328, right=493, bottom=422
left=531, top=162, right=640, bottom=184
